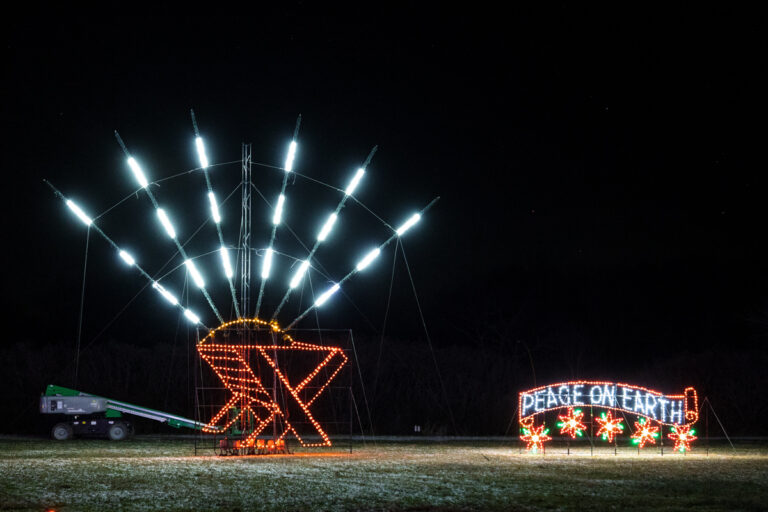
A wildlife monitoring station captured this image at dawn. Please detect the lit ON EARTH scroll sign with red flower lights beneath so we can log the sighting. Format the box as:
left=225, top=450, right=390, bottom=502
left=518, top=381, right=699, bottom=451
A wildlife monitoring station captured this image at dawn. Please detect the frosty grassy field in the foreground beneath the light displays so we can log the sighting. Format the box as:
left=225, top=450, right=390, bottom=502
left=0, top=438, right=768, bottom=511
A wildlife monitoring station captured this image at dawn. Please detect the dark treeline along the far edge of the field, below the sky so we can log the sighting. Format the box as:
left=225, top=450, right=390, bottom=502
left=0, top=337, right=768, bottom=435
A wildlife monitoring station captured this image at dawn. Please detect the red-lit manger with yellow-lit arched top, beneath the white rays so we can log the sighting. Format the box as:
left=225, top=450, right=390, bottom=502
left=197, top=318, right=347, bottom=453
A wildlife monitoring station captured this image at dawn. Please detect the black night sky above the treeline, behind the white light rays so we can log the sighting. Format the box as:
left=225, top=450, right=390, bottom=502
left=2, top=3, right=768, bottom=378
